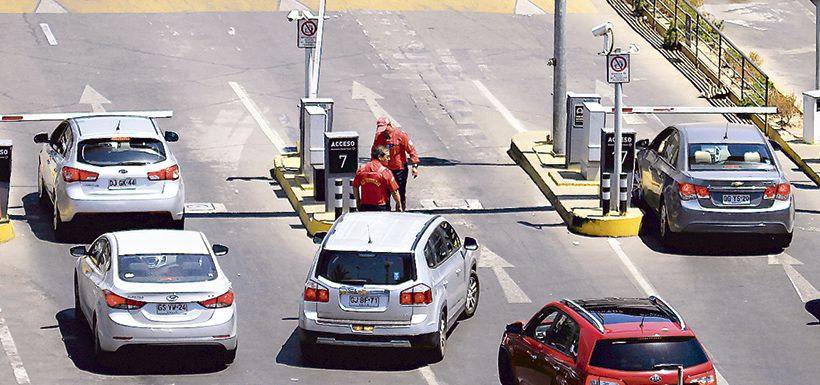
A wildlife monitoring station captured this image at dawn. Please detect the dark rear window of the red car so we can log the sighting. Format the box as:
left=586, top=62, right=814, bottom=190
left=589, top=337, right=708, bottom=371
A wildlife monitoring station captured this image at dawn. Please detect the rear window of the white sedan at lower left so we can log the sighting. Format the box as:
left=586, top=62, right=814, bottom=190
left=117, top=254, right=217, bottom=283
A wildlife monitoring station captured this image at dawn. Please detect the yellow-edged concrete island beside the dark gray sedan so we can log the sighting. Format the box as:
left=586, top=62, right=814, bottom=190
left=507, top=131, right=643, bottom=237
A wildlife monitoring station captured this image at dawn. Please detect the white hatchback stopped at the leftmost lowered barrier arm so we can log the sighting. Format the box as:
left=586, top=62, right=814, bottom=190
left=34, top=116, right=185, bottom=240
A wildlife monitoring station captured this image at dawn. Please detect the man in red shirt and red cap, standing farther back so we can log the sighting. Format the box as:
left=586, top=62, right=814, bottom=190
left=371, top=116, right=419, bottom=209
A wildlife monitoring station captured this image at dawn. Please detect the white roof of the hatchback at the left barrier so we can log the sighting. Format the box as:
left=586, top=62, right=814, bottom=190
left=71, top=116, right=159, bottom=138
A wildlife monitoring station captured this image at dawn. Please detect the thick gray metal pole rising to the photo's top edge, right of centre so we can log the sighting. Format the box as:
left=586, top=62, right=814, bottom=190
left=552, top=0, right=567, bottom=156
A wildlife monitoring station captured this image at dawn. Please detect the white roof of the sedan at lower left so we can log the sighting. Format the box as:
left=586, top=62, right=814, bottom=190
left=111, top=230, right=210, bottom=255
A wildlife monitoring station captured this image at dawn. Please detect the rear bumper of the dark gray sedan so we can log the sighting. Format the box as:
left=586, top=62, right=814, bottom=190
left=669, top=201, right=794, bottom=234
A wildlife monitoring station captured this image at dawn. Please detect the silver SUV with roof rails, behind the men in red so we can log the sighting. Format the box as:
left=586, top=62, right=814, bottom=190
left=299, top=212, right=479, bottom=361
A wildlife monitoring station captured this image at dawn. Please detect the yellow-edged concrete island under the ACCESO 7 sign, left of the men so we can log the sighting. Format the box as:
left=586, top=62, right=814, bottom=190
left=273, top=153, right=336, bottom=236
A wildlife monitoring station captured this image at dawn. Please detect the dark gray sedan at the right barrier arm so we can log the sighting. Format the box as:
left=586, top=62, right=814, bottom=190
left=633, top=123, right=794, bottom=248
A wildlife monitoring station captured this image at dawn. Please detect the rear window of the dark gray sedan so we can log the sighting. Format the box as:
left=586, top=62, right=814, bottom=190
left=689, top=143, right=775, bottom=171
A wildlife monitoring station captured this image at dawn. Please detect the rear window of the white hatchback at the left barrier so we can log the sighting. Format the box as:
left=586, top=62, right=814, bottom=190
left=77, top=137, right=165, bottom=166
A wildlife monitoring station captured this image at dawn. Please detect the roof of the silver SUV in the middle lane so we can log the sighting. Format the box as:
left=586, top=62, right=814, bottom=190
left=324, top=212, right=438, bottom=253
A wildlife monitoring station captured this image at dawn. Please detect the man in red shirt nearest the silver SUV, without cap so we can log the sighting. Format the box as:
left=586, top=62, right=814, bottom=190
left=353, top=146, right=404, bottom=211
